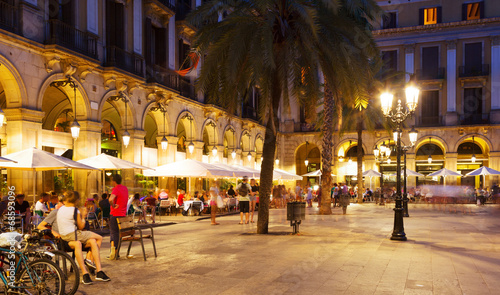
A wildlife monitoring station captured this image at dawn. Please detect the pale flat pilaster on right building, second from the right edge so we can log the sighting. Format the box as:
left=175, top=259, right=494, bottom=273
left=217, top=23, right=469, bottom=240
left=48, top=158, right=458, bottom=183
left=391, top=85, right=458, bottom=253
left=445, top=40, right=458, bottom=126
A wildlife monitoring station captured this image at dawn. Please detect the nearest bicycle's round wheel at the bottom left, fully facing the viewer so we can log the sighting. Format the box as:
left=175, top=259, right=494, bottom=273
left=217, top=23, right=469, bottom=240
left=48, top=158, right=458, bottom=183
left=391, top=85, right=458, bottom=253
left=16, top=258, right=64, bottom=295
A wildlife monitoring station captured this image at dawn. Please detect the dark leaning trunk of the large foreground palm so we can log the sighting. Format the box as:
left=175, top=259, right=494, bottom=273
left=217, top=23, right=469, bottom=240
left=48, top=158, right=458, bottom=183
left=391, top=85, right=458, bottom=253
left=257, top=78, right=281, bottom=234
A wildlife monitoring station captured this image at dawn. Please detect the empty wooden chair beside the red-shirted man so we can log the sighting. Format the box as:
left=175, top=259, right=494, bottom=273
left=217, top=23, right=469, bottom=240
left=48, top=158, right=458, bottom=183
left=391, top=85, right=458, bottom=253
left=116, top=216, right=157, bottom=261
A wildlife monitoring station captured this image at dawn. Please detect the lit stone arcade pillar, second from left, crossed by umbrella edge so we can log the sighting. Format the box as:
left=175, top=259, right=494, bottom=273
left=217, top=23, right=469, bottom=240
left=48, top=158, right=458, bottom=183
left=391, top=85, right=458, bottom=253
left=73, top=121, right=102, bottom=199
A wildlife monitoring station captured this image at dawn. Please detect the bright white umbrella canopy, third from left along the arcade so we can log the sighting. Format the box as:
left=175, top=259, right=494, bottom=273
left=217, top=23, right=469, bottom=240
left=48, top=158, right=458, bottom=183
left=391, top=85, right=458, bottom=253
left=144, top=159, right=233, bottom=177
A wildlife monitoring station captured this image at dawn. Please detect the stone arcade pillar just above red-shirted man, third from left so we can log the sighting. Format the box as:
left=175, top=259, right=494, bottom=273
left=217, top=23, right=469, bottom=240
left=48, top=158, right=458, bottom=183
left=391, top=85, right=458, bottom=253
left=122, top=129, right=146, bottom=194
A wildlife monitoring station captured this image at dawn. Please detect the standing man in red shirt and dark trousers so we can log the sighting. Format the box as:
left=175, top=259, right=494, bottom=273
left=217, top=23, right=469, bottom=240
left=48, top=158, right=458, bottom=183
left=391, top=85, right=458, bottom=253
left=109, top=174, right=128, bottom=260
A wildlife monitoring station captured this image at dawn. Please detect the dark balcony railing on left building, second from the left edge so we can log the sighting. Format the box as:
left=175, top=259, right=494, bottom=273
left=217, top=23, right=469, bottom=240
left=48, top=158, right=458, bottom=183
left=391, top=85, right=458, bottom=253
left=45, top=19, right=98, bottom=59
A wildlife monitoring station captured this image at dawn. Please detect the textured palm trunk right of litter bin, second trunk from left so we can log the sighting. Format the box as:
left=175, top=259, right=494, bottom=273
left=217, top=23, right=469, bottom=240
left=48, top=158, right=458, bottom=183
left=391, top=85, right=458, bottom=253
left=319, top=85, right=335, bottom=215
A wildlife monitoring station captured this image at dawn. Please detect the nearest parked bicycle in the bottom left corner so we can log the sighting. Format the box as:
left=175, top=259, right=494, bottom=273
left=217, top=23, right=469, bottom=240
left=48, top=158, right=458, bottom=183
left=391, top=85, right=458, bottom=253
left=0, top=235, right=65, bottom=295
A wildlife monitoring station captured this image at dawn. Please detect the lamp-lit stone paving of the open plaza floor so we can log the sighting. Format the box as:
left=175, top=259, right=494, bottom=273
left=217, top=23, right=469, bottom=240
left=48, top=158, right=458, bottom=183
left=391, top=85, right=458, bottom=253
left=79, top=204, right=500, bottom=295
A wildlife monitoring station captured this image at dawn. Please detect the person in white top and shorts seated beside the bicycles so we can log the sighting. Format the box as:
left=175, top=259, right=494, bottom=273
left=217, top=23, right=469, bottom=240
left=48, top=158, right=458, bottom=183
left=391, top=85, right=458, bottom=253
left=57, top=191, right=110, bottom=285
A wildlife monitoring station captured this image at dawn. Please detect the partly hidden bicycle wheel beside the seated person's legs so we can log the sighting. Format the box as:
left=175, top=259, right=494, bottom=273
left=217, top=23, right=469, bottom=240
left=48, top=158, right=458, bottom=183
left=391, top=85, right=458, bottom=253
left=50, top=250, right=80, bottom=295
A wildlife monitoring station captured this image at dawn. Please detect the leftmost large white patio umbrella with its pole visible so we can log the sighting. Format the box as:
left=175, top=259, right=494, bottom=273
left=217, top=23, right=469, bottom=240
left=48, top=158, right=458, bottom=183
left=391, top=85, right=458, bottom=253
left=0, top=147, right=97, bottom=201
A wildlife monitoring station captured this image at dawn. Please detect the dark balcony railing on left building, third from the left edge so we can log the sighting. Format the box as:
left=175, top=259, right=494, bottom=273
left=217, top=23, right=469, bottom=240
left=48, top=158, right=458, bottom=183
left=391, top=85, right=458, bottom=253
left=104, top=46, right=144, bottom=77
